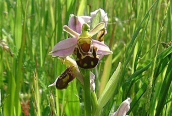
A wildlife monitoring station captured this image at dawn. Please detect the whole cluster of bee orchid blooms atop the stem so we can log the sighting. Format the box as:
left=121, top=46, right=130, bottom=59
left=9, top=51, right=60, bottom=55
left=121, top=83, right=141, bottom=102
left=49, top=9, right=112, bottom=91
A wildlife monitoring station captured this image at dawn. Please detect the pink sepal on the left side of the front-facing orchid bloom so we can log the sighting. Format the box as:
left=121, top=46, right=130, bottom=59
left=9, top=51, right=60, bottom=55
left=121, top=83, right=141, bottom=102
left=51, top=38, right=77, bottom=57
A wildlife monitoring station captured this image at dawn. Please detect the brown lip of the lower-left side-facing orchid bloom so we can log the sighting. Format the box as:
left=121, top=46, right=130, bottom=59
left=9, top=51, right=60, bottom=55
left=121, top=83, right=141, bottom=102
left=49, top=66, right=75, bottom=89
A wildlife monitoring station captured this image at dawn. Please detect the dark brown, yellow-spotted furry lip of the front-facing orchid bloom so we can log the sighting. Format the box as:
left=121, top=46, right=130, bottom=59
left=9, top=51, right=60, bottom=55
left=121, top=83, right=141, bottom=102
left=76, top=46, right=99, bottom=69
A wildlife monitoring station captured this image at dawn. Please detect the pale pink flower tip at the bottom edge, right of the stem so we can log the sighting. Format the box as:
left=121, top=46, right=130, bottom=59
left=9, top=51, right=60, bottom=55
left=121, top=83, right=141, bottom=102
left=113, top=98, right=132, bottom=116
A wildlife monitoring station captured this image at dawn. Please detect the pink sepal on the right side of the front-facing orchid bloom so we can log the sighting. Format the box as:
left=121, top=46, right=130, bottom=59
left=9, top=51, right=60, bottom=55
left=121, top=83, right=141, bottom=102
left=92, top=40, right=113, bottom=55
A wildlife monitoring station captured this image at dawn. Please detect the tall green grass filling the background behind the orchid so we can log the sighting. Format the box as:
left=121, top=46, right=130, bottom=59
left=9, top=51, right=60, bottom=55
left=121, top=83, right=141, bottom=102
left=0, top=0, right=172, bottom=116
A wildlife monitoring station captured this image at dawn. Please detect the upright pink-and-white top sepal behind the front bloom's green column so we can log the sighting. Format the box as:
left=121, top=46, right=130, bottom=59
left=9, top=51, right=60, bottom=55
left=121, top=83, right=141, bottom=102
left=69, top=14, right=91, bottom=33
